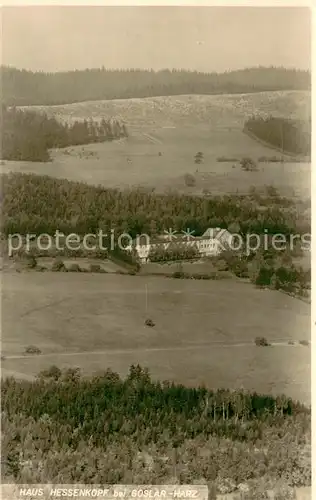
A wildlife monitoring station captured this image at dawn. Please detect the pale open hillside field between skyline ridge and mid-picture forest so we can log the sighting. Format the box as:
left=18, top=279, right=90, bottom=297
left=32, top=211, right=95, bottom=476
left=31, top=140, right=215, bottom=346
left=2, top=91, right=310, bottom=197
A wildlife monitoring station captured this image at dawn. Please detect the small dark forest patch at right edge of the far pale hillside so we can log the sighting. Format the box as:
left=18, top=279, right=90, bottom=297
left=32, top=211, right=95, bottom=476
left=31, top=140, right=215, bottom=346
left=244, top=116, right=312, bottom=158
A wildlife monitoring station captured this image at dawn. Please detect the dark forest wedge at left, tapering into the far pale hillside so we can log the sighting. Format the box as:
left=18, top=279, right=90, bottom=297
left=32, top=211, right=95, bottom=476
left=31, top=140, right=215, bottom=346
left=0, top=106, right=127, bottom=161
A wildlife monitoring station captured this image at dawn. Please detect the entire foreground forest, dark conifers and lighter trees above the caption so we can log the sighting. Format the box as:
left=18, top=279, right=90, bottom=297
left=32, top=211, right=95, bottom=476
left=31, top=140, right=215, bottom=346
left=1, top=368, right=311, bottom=499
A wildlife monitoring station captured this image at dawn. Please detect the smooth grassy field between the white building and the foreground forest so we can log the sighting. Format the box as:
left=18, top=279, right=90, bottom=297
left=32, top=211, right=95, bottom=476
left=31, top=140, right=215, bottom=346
left=2, top=272, right=310, bottom=403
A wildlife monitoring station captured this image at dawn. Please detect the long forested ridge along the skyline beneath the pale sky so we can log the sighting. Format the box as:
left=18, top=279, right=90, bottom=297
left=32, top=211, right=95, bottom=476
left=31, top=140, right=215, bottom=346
left=0, top=66, right=311, bottom=106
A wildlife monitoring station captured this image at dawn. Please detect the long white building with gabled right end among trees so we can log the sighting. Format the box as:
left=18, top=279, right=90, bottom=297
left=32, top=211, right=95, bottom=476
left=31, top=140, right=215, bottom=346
left=126, top=228, right=233, bottom=263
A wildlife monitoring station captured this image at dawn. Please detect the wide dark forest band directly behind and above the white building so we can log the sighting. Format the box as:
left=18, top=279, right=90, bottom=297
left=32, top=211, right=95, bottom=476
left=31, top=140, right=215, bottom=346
left=1, top=173, right=310, bottom=238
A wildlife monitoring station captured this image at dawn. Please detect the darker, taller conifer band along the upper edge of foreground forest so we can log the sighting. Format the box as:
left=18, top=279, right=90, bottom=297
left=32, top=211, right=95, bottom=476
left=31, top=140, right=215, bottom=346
left=1, top=365, right=308, bottom=446
